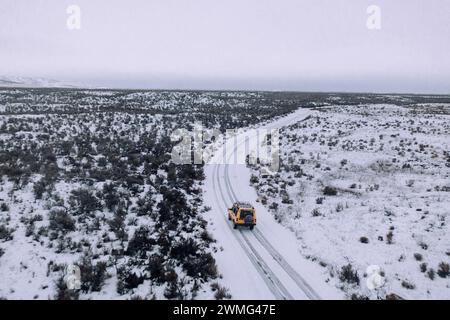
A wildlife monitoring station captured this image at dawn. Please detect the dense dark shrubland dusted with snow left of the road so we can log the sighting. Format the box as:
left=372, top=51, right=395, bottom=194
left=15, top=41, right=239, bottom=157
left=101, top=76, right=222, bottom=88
left=0, top=89, right=299, bottom=299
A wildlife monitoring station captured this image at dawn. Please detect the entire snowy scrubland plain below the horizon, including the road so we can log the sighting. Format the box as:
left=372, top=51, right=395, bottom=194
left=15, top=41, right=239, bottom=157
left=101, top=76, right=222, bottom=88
left=0, top=88, right=450, bottom=299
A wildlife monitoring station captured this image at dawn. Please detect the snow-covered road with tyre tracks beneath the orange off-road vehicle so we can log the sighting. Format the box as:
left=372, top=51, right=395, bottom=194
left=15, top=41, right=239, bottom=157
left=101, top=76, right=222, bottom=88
left=205, top=109, right=343, bottom=300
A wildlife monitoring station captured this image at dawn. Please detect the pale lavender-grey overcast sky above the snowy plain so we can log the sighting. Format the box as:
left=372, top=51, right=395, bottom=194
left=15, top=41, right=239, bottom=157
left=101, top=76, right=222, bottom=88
left=0, top=0, right=450, bottom=93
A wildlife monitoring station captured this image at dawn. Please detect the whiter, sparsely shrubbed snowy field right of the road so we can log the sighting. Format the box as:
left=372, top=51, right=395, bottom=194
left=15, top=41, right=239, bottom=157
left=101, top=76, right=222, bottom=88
left=250, top=103, right=450, bottom=299
